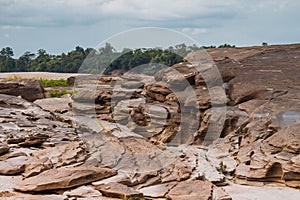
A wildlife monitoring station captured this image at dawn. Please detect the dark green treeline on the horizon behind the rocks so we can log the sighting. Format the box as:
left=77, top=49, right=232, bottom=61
left=0, top=43, right=235, bottom=73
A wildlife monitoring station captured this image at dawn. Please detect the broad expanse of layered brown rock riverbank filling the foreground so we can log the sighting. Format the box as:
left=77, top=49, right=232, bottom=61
left=0, top=45, right=300, bottom=200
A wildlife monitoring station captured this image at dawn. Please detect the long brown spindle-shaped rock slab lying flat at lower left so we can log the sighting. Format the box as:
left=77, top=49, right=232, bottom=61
left=14, top=167, right=117, bottom=192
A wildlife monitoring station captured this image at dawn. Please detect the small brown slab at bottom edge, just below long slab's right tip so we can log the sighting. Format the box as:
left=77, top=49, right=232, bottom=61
left=96, top=183, right=143, bottom=199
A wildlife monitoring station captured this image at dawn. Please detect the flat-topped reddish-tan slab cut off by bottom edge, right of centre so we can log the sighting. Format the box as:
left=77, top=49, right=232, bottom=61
left=166, top=180, right=213, bottom=200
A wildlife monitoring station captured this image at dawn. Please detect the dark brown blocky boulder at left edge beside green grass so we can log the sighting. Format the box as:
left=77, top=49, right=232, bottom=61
left=0, top=79, right=44, bottom=102
